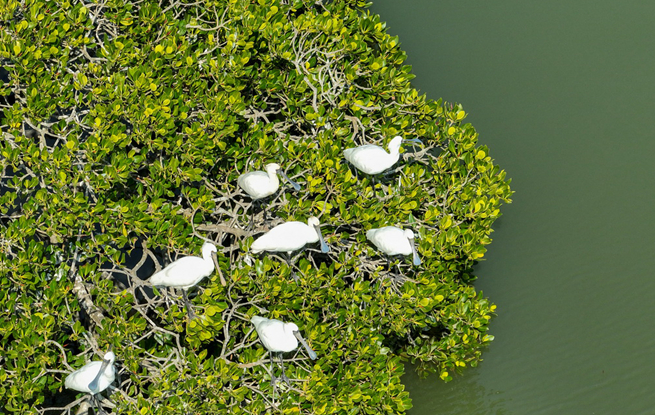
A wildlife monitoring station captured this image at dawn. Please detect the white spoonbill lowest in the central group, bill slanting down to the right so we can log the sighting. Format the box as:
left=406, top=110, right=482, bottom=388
left=250, top=316, right=317, bottom=387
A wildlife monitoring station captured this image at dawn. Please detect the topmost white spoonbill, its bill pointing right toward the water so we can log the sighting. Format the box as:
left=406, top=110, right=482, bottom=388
left=343, top=136, right=421, bottom=174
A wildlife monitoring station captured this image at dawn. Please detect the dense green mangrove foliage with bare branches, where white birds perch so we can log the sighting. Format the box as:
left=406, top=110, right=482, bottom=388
left=0, top=0, right=511, bottom=414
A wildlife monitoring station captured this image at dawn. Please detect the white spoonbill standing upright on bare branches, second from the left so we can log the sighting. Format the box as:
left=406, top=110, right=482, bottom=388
left=150, top=242, right=226, bottom=319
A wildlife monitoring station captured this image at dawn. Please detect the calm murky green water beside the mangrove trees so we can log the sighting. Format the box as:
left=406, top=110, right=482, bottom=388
left=372, top=0, right=655, bottom=415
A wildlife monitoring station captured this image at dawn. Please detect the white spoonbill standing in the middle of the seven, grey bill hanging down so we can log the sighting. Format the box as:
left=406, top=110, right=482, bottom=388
left=250, top=216, right=330, bottom=279
